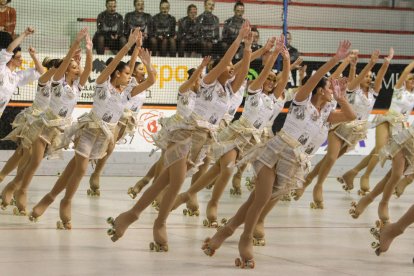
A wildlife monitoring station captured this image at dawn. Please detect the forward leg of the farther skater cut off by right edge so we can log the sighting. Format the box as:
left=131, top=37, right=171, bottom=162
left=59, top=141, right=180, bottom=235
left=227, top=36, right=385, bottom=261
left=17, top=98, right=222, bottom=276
left=358, top=122, right=390, bottom=195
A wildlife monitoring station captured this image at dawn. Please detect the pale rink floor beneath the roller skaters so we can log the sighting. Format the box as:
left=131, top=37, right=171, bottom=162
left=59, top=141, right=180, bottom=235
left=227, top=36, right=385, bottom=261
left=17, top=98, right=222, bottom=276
left=0, top=177, right=414, bottom=276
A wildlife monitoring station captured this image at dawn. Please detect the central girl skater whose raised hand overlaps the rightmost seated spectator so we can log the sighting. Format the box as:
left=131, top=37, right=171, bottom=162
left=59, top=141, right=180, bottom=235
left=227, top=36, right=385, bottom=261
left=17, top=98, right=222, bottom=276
left=108, top=21, right=250, bottom=251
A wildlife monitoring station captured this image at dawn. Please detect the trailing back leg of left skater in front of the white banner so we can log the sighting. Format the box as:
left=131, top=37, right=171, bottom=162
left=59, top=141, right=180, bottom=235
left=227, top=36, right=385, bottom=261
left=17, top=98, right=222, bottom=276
left=29, top=157, right=75, bottom=221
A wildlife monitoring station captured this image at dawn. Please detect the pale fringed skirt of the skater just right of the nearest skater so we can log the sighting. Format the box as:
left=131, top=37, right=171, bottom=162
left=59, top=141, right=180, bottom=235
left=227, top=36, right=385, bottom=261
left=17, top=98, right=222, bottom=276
left=332, top=120, right=368, bottom=151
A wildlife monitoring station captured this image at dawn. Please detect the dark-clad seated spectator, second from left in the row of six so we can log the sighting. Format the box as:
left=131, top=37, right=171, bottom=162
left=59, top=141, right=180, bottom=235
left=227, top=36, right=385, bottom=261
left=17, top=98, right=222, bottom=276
left=124, top=0, right=152, bottom=50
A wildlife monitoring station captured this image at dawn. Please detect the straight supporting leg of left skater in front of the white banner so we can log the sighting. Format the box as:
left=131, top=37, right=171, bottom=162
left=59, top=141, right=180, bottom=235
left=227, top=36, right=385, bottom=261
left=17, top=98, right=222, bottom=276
left=58, top=153, right=89, bottom=229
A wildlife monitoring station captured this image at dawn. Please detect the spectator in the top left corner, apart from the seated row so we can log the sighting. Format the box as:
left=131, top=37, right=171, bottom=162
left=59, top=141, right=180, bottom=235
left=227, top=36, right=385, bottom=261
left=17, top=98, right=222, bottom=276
left=0, top=0, right=16, bottom=45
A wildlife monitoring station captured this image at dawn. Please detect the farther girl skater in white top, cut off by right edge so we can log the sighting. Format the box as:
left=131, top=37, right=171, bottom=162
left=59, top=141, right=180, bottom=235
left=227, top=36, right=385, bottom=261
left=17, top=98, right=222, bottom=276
left=342, top=62, right=414, bottom=198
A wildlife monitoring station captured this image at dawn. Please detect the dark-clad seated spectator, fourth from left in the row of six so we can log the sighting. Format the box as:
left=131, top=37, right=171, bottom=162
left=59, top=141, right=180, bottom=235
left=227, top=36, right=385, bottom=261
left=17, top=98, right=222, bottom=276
left=177, top=4, right=198, bottom=57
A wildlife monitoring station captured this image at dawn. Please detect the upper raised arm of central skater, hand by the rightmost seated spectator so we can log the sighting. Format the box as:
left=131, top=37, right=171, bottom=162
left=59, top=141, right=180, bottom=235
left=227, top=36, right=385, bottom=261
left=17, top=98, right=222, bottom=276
left=204, top=20, right=250, bottom=84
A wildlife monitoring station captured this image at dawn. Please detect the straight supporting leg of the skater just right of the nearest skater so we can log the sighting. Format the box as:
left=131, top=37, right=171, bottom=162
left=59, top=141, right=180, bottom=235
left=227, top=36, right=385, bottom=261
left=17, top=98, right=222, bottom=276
left=311, top=131, right=345, bottom=209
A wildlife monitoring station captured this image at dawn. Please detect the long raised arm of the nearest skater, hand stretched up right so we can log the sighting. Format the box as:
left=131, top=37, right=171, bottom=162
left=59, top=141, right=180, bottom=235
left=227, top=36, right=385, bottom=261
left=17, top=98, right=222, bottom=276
left=295, top=40, right=351, bottom=102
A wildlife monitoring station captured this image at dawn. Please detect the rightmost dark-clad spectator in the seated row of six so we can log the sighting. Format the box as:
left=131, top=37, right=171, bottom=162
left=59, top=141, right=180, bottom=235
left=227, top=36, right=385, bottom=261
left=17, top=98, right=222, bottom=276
left=221, top=1, right=244, bottom=55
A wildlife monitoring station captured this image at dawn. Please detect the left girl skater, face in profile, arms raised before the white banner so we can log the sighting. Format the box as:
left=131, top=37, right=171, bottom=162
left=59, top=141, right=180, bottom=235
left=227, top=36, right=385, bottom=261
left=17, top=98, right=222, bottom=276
left=29, top=28, right=155, bottom=229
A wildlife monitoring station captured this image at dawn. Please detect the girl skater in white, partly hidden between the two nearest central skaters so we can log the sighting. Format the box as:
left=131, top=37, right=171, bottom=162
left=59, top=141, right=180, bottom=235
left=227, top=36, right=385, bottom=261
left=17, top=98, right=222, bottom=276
left=173, top=34, right=290, bottom=227
